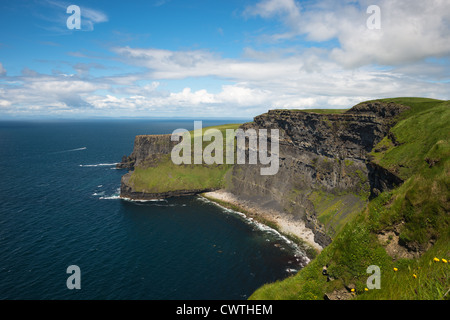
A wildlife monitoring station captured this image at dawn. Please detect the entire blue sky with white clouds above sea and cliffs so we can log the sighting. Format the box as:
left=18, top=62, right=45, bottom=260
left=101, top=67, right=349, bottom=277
left=0, top=0, right=450, bottom=120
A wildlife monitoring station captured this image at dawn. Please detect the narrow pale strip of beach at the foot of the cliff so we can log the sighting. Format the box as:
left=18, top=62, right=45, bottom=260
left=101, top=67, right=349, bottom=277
left=204, top=190, right=322, bottom=251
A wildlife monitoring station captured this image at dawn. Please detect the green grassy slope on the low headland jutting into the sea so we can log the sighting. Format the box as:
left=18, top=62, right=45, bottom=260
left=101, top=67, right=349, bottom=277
left=130, top=124, right=240, bottom=193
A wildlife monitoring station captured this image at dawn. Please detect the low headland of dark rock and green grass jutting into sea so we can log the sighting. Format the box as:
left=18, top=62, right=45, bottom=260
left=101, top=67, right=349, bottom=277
left=120, top=124, right=240, bottom=199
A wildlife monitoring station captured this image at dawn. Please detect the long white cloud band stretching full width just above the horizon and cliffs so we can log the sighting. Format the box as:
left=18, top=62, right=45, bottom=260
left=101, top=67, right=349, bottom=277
left=0, top=41, right=449, bottom=117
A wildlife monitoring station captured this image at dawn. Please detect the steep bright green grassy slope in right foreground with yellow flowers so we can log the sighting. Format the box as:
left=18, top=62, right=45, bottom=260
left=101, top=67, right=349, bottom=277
left=250, top=98, right=450, bottom=299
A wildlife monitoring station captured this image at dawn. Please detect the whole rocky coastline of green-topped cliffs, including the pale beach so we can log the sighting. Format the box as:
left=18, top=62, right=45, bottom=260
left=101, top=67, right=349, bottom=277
left=118, top=98, right=450, bottom=299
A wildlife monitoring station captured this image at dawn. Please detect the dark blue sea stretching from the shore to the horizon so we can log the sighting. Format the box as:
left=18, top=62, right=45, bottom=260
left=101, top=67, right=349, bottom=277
left=0, top=120, right=304, bottom=300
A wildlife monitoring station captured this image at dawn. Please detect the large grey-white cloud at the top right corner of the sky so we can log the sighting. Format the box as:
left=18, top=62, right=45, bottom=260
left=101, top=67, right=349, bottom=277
left=245, top=0, right=450, bottom=68
